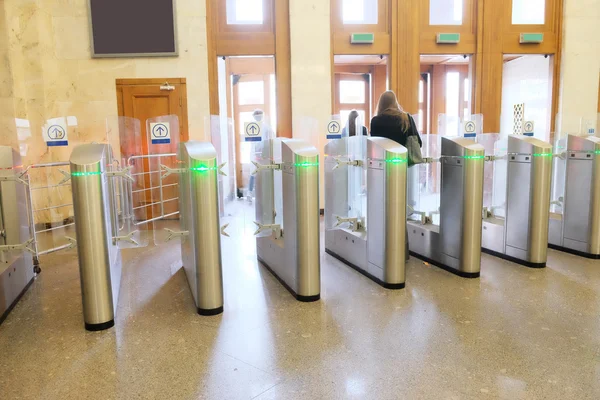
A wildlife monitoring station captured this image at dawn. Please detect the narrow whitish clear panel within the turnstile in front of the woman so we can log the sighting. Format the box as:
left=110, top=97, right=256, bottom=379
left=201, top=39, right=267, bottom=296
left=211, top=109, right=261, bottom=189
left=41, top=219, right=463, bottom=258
left=347, top=135, right=367, bottom=227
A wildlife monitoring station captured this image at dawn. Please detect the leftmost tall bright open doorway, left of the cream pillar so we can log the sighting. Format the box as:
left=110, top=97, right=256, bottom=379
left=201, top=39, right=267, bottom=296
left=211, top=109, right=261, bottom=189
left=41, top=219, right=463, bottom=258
left=218, top=56, right=277, bottom=198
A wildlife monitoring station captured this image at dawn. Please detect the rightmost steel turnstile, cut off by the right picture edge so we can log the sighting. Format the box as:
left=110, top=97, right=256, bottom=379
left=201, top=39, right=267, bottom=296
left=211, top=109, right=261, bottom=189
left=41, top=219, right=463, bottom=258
left=549, top=135, right=600, bottom=259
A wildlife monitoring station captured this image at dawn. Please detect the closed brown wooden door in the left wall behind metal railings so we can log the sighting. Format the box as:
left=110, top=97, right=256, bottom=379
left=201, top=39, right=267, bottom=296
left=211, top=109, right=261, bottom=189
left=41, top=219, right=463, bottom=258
left=117, top=78, right=189, bottom=219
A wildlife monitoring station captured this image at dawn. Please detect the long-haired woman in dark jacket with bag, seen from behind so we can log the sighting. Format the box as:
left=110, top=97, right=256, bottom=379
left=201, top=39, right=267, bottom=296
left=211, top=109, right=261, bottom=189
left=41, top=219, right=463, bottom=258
left=371, top=90, right=423, bottom=261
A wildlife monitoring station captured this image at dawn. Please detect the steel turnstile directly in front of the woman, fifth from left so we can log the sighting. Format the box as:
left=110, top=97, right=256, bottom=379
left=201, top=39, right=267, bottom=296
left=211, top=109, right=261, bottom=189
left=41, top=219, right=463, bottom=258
left=325, top=136, right=408, bottom=289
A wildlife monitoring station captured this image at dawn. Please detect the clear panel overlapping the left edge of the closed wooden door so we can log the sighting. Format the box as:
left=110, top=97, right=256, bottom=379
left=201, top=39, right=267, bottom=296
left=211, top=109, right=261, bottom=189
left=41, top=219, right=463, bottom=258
left=106, top=117, right=152, bottom=248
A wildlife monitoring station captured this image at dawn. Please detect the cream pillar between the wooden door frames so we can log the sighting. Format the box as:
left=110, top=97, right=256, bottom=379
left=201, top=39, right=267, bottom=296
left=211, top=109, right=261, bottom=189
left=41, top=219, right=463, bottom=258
left=290, top=0, right=332, bottom=208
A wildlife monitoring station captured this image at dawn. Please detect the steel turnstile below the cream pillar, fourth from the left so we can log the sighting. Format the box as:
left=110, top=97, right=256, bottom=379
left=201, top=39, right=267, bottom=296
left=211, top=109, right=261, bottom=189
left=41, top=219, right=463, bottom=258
left=256, top=139, right=321, bottom=302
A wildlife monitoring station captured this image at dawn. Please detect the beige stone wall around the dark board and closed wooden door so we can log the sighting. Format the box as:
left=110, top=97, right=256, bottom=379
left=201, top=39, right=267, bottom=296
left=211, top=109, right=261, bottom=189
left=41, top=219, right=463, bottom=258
left=0, top=0, right=209, bottom=221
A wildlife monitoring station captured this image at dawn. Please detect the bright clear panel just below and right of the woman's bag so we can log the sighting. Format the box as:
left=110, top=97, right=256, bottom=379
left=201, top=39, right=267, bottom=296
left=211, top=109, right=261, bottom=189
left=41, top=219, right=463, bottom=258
left=407, top=135, right=442, bottom=225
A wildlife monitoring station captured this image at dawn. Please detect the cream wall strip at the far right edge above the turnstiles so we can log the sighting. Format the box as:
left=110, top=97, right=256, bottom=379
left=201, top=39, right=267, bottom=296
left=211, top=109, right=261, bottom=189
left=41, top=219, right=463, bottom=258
left=559, top=0, right=600, bottom=134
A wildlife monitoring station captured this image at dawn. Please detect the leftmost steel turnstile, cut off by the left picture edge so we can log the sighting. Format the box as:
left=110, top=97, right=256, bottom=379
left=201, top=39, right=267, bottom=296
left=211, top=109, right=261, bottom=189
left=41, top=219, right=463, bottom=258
left=0, top=146, right=34, bottom=323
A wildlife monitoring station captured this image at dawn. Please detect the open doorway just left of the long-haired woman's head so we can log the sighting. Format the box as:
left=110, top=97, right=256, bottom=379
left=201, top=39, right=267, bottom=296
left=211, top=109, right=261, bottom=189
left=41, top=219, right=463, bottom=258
left=333, top=55, right=388, bottom=130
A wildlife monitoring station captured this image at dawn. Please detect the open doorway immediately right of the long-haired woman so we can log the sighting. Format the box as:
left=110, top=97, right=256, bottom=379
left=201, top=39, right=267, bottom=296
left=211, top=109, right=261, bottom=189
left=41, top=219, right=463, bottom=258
left=415, top=55, right=473, bottom=136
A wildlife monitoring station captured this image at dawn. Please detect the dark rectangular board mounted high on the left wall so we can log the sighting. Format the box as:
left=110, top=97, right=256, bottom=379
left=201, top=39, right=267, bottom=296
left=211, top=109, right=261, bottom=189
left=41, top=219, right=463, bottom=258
left=89, top=0, right=177, bottom=57
